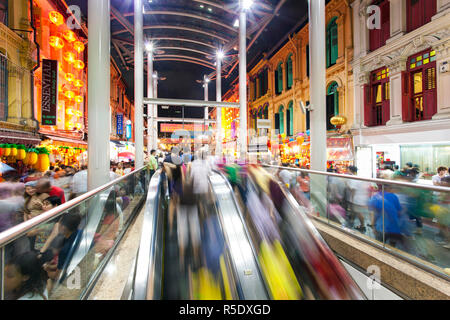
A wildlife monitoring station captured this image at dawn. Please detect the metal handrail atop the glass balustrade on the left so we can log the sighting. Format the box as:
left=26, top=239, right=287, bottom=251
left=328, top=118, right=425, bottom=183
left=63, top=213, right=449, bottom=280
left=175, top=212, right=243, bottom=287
left=0, top=167, right=146, bottom=248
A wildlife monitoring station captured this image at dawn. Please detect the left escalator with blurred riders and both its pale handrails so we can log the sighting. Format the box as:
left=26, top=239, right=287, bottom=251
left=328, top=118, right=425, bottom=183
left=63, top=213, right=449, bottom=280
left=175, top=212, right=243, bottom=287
left=132, top=171, right=269, bottom=300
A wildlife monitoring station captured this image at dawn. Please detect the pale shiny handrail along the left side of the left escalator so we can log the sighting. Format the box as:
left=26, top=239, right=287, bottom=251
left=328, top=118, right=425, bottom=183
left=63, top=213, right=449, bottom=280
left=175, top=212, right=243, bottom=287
left=132, top=169, right=163, bottom=300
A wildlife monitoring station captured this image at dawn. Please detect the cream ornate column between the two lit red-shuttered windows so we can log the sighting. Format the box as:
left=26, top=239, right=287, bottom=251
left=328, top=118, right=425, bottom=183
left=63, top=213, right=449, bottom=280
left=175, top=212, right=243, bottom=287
left=386, top=57, right=407, bottom=126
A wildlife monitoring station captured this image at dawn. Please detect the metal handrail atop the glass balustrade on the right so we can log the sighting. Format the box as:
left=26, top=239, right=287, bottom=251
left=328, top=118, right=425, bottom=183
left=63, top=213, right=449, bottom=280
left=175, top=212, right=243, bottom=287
left=262, top=165, right=450, bottom=192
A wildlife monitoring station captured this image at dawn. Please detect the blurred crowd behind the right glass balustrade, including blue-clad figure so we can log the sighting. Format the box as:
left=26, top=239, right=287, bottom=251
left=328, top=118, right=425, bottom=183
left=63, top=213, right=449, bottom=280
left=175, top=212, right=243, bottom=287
left=276, top=163, right=450, bottom=268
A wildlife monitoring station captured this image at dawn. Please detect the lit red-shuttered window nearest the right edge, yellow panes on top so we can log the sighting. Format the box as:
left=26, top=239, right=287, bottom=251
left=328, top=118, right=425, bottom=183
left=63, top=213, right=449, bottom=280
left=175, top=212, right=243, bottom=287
left=404, top=49, right=437, bottom=121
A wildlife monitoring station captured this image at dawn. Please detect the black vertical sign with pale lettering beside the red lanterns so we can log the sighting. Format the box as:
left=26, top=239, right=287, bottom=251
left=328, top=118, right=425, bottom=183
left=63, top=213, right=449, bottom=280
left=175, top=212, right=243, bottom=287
left=41, top=59, right=58, bottom=126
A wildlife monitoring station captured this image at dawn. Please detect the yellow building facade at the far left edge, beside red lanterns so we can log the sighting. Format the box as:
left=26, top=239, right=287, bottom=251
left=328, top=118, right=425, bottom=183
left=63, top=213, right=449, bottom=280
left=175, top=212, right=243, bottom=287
left=0, top=0, right=39, bottom=144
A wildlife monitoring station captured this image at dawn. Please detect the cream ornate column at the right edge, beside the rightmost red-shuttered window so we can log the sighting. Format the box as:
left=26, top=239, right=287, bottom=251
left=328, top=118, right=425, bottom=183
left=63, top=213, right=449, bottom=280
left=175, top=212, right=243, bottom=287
left=433, top=38, right=450, bottom=119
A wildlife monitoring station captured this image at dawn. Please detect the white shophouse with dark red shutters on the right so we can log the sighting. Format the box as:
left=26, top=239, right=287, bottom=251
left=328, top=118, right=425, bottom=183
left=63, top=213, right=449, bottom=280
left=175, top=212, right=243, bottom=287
left=351, top=0, right=450, bottom=178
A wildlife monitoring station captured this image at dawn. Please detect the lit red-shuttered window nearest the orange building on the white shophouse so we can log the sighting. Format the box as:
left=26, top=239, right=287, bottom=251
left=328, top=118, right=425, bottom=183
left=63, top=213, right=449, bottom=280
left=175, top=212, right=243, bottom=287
left=364, top=68, right=390, bottom=127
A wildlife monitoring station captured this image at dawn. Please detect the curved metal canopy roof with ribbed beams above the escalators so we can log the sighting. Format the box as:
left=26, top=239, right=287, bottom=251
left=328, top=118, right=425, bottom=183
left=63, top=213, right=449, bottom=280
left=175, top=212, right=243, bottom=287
left=111, top=0, right=286, bottom=79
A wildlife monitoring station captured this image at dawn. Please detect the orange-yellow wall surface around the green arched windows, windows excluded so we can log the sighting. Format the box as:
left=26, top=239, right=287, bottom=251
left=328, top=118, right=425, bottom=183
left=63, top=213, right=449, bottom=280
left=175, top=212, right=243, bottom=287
left=248, top=0, right=353, bottom=135
